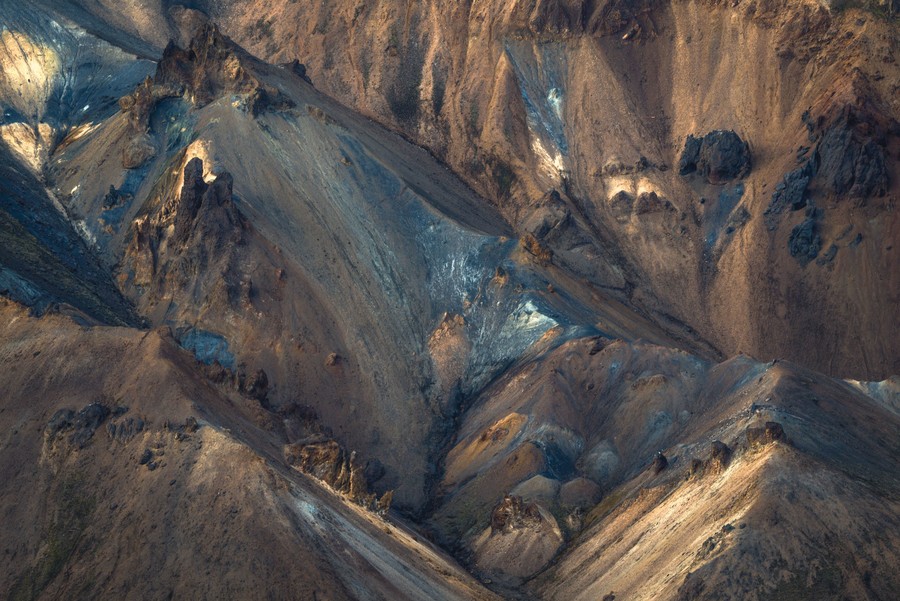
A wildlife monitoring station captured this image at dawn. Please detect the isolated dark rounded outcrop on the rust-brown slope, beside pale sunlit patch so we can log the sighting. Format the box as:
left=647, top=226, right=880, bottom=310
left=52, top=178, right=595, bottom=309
left=678, top=130, right=750, bottom=184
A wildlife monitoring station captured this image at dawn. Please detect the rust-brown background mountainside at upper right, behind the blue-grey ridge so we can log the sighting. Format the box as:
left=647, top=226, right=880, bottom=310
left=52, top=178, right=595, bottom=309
left=96, top=0, right=900, bottom=378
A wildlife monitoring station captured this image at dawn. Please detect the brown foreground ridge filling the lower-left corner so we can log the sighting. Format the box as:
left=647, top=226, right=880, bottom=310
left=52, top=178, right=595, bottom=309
left=0, top=300, right=493, bottom=599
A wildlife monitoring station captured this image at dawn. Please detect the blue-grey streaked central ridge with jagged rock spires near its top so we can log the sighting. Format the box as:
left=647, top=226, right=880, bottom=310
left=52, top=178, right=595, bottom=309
left=29, top=12, right=724, bottom=510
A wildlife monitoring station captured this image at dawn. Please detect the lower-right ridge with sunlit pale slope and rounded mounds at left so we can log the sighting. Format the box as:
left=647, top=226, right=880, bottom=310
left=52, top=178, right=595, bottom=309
left=432, top=338, right=900, bottom=599
